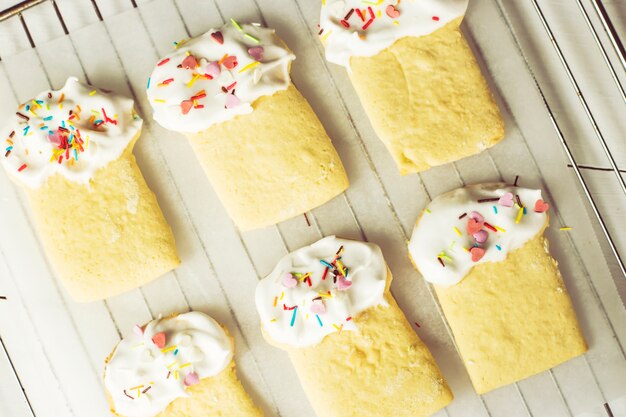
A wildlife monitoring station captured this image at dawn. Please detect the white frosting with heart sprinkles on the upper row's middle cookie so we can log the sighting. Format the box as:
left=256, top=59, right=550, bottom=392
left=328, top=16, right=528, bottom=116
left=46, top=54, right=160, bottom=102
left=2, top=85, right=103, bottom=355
left=148, top=20, right=295, bottom=132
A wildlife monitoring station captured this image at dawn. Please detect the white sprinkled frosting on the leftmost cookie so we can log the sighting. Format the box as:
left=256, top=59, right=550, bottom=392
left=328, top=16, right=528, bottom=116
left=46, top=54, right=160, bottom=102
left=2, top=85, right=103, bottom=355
left=0, top=77, right=142, bottom=188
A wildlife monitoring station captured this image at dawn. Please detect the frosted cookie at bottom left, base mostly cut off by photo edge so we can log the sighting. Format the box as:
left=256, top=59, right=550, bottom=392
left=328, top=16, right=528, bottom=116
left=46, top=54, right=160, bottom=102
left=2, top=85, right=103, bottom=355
left=104, top=312, right=263, bottom=417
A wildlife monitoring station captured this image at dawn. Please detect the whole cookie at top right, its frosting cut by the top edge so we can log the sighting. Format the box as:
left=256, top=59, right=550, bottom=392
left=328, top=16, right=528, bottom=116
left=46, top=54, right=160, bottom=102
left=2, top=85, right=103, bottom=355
left=320, top=0, right=504, bottom=174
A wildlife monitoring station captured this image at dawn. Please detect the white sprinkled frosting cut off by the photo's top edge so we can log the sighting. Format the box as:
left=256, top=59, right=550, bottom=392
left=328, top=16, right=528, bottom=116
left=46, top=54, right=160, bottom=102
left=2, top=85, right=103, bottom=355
left=320, top=0, right=468, bottom=68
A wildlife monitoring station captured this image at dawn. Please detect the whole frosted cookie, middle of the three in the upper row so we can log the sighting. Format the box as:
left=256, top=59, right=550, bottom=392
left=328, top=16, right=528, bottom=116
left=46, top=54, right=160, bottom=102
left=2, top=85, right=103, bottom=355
left=148, top=20, right=348, bottom=230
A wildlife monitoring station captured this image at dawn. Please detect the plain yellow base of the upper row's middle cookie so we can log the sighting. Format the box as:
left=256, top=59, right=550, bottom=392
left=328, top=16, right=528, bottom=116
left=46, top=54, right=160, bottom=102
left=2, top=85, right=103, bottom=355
left=187, top=85, right=348, bottom=230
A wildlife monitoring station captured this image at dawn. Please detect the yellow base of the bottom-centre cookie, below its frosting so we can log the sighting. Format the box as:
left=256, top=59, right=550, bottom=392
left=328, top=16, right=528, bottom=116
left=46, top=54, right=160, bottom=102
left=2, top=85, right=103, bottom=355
left=288, top=272, right=453, bottom=417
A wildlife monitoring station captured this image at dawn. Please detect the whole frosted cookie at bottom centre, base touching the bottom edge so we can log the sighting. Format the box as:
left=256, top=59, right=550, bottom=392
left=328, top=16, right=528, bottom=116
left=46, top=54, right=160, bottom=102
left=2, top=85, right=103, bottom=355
left=256, top=236, right=452, bottom=417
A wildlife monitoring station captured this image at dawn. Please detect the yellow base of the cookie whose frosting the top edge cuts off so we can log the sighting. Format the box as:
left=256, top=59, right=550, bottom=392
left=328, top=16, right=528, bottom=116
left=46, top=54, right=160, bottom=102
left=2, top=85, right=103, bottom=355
left=350, top=18, right=504, bottom=175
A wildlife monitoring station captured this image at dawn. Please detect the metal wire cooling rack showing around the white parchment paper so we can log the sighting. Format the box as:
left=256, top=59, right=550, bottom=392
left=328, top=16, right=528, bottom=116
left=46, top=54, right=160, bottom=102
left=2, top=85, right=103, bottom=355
left=0, top=0, right=626, bottom=417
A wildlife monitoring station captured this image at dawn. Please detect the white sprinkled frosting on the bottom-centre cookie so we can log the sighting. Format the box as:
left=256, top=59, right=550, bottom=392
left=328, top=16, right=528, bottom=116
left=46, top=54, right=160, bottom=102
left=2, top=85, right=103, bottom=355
left=255, top=236, right=387, bottom=348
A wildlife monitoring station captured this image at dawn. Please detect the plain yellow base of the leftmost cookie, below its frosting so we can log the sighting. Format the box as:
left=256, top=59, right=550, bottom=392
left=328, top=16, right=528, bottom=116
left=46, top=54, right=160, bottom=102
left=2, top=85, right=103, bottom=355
left=27, top=134, right=180, bottom=302
